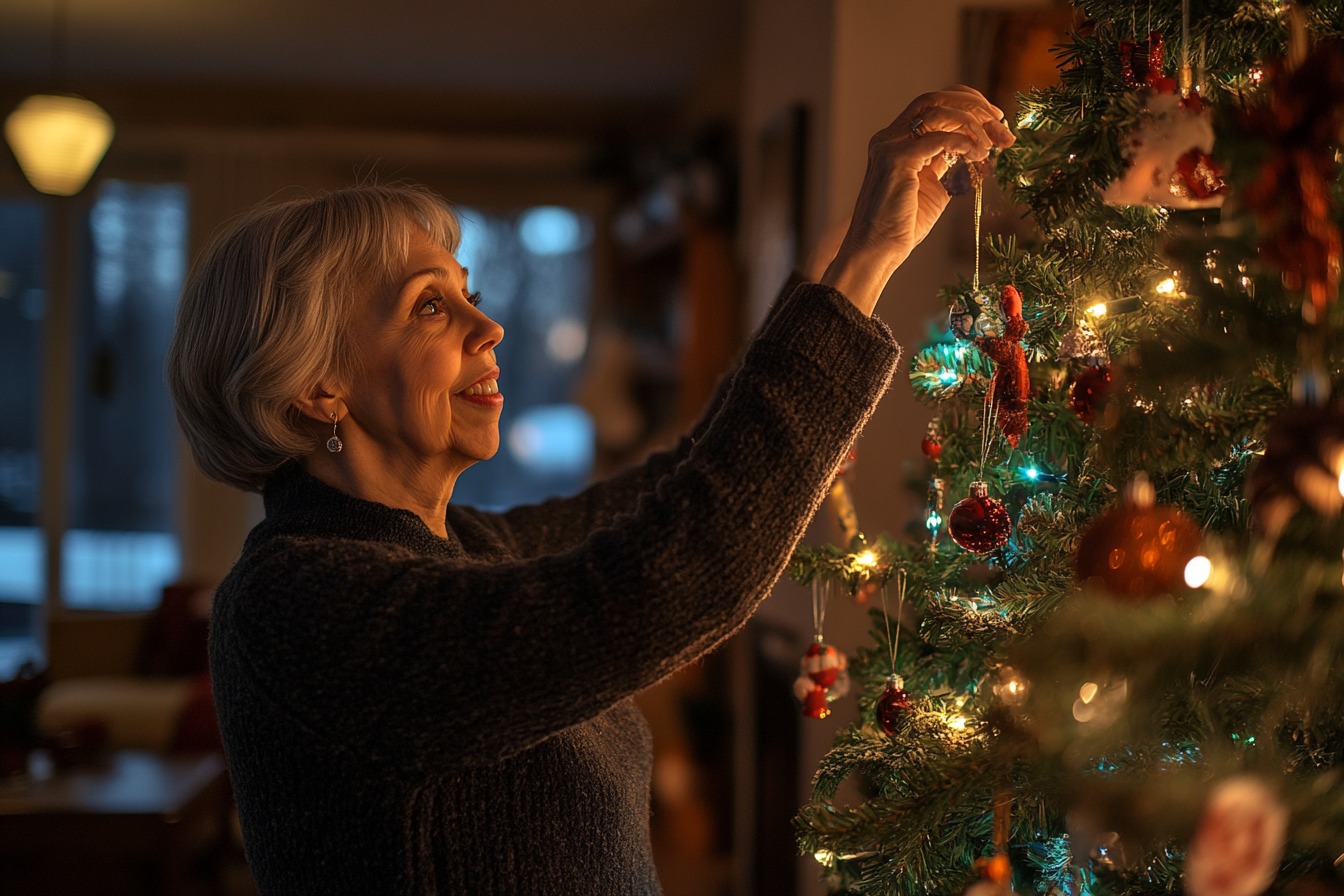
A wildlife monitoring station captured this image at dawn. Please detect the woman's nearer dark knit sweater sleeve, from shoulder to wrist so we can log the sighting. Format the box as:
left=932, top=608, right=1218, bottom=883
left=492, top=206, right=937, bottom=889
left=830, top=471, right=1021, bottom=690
left=212, top=285, right=900, bottom=767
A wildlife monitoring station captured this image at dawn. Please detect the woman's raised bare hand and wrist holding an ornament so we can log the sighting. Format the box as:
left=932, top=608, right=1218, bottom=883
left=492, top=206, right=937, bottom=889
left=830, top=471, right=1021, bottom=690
left=821, top=86, right=1013, bottom=314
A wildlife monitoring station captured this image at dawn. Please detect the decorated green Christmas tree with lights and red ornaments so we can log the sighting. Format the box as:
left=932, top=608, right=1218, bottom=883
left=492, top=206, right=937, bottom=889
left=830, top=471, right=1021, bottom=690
left=792, top=0, right=1344, bottom=896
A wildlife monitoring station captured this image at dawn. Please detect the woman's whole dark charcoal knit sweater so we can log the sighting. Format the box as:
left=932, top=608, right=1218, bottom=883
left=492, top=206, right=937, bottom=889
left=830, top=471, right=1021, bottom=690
left=210, top=276, right=899, bottom=896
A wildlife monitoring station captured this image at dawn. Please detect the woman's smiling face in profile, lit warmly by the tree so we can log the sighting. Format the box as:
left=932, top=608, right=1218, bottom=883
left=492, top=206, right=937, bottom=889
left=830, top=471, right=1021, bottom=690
left=343, top=227, right=504, bottom=472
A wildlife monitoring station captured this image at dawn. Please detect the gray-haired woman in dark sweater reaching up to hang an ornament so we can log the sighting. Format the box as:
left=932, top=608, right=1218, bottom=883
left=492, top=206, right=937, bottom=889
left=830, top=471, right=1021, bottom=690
left=168, top=87, right=1012, bottom=895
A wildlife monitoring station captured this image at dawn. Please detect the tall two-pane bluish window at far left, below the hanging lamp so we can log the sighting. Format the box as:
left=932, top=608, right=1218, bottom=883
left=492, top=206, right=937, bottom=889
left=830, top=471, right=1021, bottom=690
left=0, top=180, right=187, bottom=671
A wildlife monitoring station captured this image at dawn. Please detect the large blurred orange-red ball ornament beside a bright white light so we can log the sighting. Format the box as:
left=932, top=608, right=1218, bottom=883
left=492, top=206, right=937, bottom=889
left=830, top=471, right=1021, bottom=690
left=1074, top=474, right=1203, bottom=600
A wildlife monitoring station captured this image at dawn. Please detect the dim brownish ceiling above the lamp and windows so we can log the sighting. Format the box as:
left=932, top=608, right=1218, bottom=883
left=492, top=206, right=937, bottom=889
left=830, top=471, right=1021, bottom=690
left=0, top=0, right=742, bottom=101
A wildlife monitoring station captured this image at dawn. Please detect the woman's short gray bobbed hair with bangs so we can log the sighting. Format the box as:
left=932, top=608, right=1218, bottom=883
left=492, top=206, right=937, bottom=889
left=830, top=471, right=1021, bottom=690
left=168, top=185, right=461, bottom=490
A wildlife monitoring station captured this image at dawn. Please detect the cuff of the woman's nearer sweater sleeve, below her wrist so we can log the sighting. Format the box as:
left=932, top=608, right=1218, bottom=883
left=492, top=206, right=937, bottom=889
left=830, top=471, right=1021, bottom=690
left=758, top=283, right=900, bottom=394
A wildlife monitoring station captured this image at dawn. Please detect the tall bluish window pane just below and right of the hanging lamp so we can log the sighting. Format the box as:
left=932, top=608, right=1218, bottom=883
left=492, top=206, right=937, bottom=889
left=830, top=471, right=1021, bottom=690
left=60, top=180, right=187, bottom=610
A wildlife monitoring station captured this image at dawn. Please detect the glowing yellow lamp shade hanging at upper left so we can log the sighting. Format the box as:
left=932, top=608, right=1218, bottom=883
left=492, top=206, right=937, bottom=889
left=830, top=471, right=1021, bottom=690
left=4, top=94, right=113, bottom=196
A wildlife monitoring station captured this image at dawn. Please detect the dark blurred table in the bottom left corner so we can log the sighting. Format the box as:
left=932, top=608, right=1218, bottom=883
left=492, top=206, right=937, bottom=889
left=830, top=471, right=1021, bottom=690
left=0, top=750, right=230, bottom=896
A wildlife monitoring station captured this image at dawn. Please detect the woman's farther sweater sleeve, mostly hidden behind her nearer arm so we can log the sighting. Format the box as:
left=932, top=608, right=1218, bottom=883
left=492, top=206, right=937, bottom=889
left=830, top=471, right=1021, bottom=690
left=489, top=271, right=806, bottom=557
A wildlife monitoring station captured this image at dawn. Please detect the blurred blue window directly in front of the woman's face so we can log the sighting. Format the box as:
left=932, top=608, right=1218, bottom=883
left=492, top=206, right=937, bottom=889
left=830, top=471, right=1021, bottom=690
left=453, top=206, right=593, bottom=509
